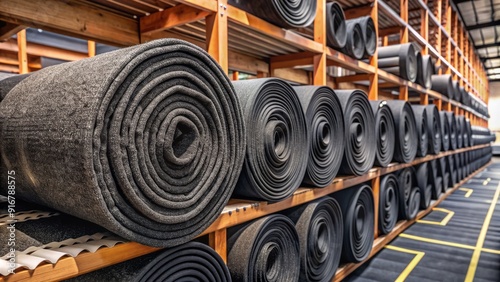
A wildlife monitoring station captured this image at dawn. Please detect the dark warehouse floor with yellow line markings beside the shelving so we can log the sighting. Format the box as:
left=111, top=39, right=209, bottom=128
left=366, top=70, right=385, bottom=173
left=346, top=162, right=500, bottom=282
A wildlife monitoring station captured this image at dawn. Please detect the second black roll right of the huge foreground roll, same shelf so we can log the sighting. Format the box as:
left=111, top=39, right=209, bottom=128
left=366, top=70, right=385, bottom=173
left=294, top=86, right=345, bottom=187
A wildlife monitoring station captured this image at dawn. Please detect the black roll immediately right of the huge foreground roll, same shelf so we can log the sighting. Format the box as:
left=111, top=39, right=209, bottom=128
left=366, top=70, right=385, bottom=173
left=233, top=78, right=309, bottom=201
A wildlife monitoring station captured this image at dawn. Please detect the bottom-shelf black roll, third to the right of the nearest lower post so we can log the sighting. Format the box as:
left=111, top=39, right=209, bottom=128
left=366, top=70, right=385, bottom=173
left=333, top=184, right=375, bottom=262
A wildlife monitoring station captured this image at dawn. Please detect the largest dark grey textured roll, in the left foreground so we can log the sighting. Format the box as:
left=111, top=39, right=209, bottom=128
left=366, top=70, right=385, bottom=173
left=0, top=39, right=246, bottom=247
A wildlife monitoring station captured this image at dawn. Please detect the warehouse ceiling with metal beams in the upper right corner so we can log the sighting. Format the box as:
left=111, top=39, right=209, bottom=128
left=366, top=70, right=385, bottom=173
left=452, top=0, right=500, bottom=81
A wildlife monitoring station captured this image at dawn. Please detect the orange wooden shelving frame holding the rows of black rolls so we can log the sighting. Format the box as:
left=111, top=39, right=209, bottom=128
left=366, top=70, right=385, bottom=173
left=0, top=0, right=489, bottom=281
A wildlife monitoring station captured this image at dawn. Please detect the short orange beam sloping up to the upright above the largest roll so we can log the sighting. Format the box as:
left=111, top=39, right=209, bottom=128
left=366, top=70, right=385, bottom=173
left=140, top=4, right=212, bottom=35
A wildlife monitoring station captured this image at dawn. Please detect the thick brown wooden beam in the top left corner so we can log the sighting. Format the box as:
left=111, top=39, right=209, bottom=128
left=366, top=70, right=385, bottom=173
left=0, top=0, right=139, bottom=46
